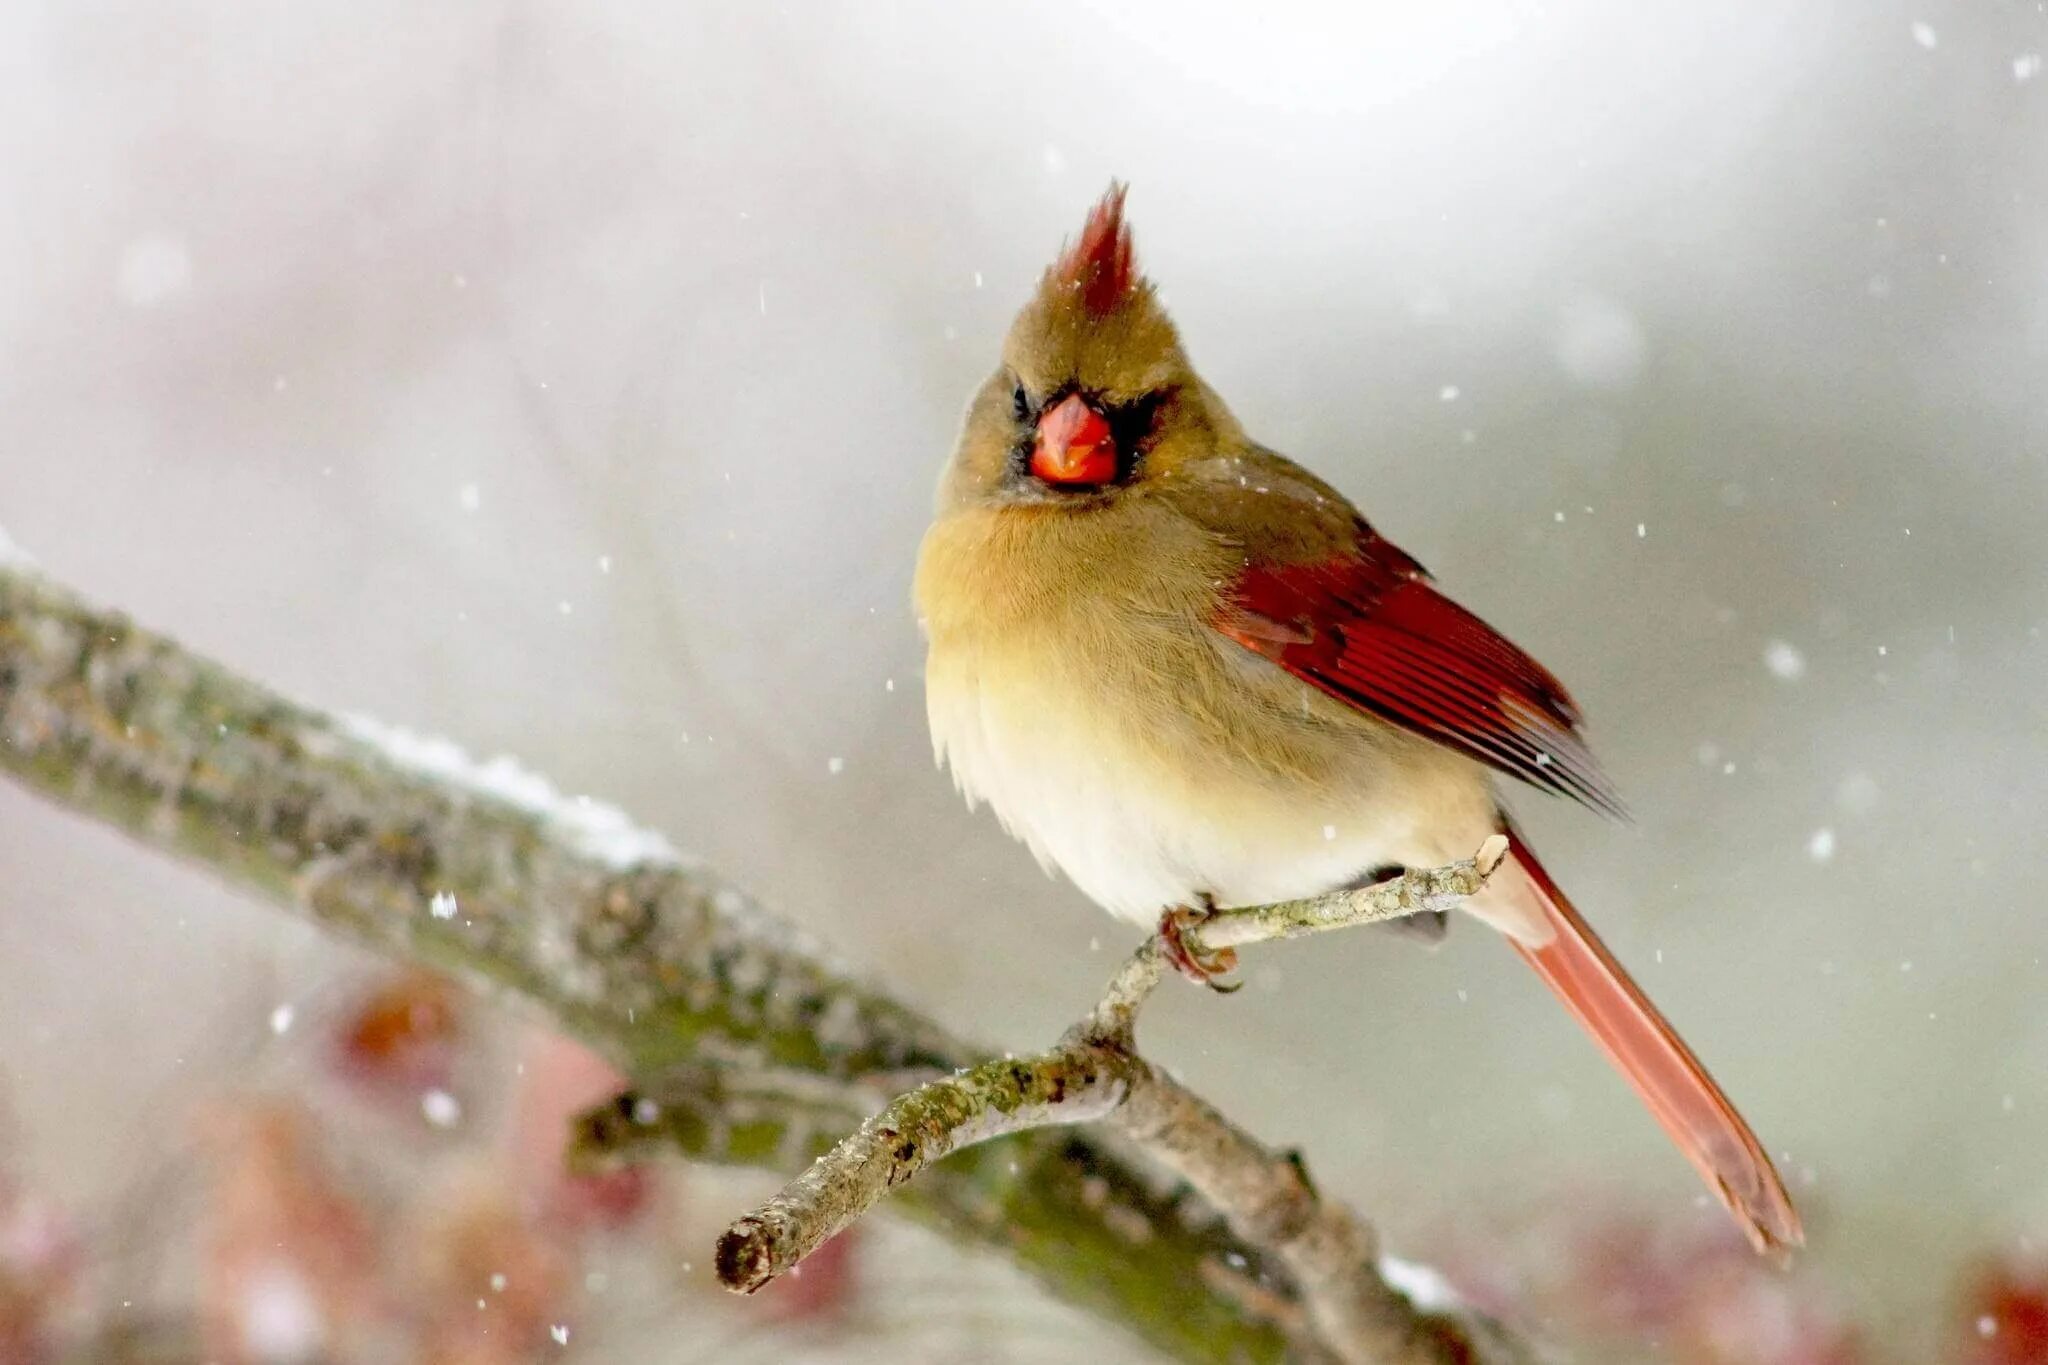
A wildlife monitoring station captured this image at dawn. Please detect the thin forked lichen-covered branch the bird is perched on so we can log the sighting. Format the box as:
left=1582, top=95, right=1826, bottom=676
left=717, top=855, right=1524, bottom=1365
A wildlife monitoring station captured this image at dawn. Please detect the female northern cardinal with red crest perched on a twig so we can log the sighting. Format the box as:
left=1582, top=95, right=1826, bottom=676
left=918, top=186, right=1804, bottom=1252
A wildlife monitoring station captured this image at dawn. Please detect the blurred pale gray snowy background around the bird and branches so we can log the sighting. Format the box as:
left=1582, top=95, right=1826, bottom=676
left=0, top=0, right=2048, bottom=1359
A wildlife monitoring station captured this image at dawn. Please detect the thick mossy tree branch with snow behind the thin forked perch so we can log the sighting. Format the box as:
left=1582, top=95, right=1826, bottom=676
left=0, top=560, right=1523, bottom=1361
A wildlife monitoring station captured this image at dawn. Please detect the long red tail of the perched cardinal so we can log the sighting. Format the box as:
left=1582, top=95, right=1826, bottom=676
left=1495, top=839, right=1806, bottom=1259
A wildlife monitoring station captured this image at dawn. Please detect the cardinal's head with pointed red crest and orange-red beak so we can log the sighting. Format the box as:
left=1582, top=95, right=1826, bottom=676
left=940, top=184, right=1241, bottom=510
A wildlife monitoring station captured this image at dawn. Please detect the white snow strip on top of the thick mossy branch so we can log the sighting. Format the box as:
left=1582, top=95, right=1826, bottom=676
left=336, top=714, right=686, bottom=872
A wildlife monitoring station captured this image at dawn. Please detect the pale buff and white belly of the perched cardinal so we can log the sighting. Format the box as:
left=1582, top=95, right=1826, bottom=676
left=926, top=622, right=1495, bottom=925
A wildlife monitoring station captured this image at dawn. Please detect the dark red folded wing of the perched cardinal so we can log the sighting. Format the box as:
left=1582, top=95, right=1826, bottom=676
left=1217, top=530, right=1626, bottom=819
